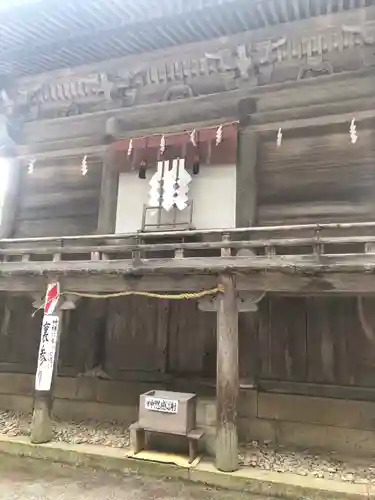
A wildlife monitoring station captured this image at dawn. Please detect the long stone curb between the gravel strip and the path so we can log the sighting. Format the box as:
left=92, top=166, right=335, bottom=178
left=0, top=436, right=375, bottom=500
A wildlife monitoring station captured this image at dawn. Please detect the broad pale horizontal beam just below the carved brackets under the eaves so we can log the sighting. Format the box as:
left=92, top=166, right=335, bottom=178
left=17, top=68, right=374, bottom=154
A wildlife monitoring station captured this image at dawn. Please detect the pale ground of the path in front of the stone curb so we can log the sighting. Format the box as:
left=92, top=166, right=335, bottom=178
left=0, top=455, right=269, bottom=500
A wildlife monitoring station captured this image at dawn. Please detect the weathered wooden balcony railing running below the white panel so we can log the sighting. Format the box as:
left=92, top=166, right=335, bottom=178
left=0, top=222, right=375, bottom=265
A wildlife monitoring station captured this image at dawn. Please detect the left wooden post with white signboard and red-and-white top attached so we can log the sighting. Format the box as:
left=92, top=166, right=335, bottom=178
left=31, top=284, right=63, bottom=444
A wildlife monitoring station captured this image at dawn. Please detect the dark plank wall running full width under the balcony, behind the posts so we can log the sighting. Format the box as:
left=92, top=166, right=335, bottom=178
left=0, top=294, right=375, bottom=396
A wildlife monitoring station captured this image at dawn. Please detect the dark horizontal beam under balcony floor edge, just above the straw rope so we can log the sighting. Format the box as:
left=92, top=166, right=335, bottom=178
left=0, top=267, right=375, bottom=296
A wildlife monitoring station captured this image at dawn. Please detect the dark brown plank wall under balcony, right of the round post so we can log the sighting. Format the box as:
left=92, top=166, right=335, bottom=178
left=256, top=297, right=375, bottom=387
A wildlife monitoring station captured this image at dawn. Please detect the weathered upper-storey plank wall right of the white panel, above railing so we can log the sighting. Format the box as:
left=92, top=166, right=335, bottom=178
left=257, top=129, right=375, bottom=225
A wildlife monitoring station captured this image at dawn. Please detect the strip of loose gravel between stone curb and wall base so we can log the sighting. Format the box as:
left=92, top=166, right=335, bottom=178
left=0, top=412, right=375, bottom=484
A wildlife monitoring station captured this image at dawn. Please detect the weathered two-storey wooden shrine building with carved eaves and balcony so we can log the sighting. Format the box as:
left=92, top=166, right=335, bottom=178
left=0, top=0, right=375, bottom=470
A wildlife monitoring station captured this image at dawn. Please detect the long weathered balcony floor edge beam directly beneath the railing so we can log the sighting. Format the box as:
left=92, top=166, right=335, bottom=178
left=0, top=254, right=375, bottom=277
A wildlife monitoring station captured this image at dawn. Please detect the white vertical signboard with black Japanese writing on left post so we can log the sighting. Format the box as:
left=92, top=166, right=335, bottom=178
left=35, top=315, right=60, bottom=391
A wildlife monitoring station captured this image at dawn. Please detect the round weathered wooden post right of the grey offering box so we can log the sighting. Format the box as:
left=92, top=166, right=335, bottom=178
left=216, top=274, right=239, bottom=472
